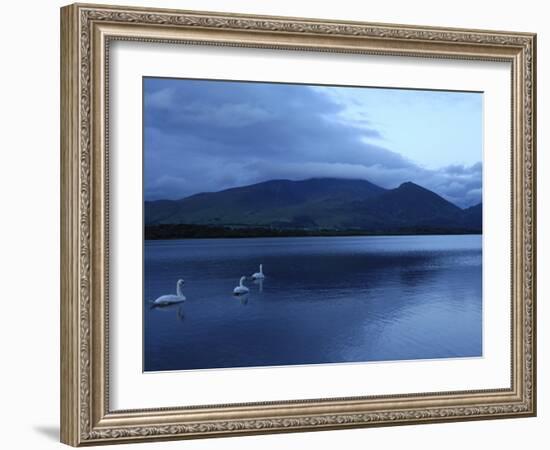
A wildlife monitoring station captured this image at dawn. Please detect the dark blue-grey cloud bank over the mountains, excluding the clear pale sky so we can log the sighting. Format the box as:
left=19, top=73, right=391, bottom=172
left=144, top=78, right=481, bottom=206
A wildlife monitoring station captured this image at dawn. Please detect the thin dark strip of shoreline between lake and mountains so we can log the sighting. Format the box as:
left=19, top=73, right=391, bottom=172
left=144, top=224, right=482, bottom=241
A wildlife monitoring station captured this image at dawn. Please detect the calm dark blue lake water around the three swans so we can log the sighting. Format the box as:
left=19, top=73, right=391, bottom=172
left=144, top=236, right=482, bottom=371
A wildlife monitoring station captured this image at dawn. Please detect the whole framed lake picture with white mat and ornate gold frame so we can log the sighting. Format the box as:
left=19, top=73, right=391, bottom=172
left=61, top=4, right=536, bottom=446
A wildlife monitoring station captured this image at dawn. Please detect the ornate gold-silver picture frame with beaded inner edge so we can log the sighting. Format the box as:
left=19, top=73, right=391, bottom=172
left=61, top=4, right=536, bottom=446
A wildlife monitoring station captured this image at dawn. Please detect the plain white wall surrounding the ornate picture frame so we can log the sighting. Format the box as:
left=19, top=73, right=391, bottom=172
left=0, top=0, right=550, bottom=450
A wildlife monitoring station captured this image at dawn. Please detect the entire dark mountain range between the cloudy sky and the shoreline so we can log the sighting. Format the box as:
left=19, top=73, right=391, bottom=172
left=145, top=178, right=481, bottom=237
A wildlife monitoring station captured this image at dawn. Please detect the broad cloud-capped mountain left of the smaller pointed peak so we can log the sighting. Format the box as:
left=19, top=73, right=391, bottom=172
left=145, top=178, right=385, bottom=228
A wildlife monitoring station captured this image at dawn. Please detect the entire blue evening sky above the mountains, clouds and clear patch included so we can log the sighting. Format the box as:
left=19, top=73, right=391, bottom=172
left=143, top=77, right=483, bottom=207
